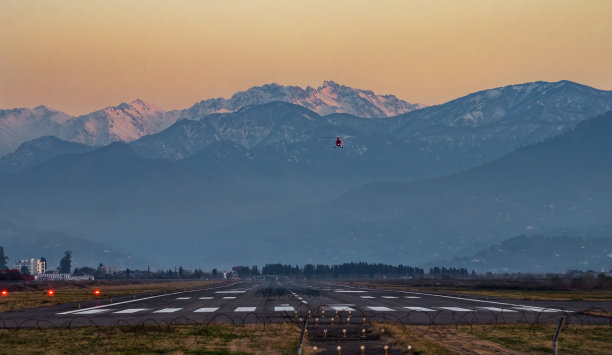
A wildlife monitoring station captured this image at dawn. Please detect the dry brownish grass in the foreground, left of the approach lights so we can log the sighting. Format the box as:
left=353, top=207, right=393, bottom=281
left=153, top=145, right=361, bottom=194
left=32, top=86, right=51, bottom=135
left=0, top=324, right=299, bottom=355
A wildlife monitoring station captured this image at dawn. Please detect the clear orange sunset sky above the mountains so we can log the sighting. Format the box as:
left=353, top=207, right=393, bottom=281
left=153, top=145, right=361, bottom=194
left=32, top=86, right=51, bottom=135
left=0, top=0, right=612, bottom=114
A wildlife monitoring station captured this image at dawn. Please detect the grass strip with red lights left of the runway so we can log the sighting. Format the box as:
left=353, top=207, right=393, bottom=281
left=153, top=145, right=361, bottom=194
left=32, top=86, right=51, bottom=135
left=0, top=281, right=226, bottom=312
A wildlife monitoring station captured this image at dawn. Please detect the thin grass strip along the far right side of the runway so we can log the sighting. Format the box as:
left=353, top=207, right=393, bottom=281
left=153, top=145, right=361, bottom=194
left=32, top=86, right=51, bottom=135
left=342, top=281, right=612, bottom=301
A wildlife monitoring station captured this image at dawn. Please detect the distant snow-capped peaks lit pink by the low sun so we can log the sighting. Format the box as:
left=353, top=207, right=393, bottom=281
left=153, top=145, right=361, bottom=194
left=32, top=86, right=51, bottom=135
left=0, top=81, right=422, bottom=156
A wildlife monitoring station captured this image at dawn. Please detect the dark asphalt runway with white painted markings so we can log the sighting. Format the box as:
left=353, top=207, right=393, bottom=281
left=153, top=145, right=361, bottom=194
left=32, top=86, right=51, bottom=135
left=0, top=281, right=612, bottom=327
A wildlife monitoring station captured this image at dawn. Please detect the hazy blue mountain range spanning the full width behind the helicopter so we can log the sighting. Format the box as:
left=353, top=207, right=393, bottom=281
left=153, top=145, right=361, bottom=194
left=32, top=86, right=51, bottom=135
left=0, top=81, right=612, bottom=268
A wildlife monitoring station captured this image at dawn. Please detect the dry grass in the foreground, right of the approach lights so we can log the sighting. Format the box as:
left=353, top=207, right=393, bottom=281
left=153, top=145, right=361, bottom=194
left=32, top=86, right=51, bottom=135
left=378, top=323, right=612, bottom=355
